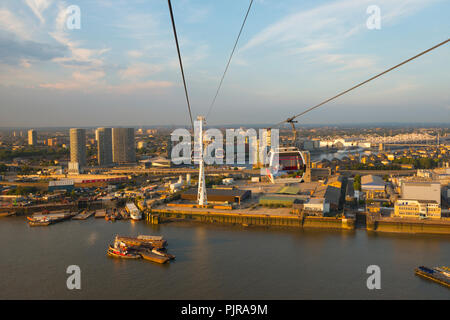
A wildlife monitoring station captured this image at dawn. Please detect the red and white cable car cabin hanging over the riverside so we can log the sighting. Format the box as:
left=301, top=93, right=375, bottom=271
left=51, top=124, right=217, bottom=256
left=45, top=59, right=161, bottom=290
left=269, top=147, right=306, bottom=172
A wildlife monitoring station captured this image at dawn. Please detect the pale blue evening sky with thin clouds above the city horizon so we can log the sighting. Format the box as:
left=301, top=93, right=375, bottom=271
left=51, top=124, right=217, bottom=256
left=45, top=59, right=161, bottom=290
left=0, top=0, right=450, bottom=127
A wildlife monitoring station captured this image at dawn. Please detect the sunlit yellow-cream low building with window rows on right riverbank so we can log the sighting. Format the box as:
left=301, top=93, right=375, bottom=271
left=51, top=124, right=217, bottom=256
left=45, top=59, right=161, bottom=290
left=394, top=199, right=441, bottom=219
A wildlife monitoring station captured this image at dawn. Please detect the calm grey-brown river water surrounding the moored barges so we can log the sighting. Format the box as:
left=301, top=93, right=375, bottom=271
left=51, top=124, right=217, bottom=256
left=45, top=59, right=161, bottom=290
left=0, top=217, right=450, bottom=299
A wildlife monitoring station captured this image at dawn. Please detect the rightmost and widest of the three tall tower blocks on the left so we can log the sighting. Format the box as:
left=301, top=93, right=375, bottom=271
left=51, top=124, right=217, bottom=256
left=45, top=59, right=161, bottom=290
left=112, top=128, right=136, bottom=163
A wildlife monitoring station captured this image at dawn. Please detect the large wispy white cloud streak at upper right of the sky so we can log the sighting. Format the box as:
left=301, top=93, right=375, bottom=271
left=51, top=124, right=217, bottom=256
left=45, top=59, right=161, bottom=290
left=241, top=0, right=439, bottom=53
